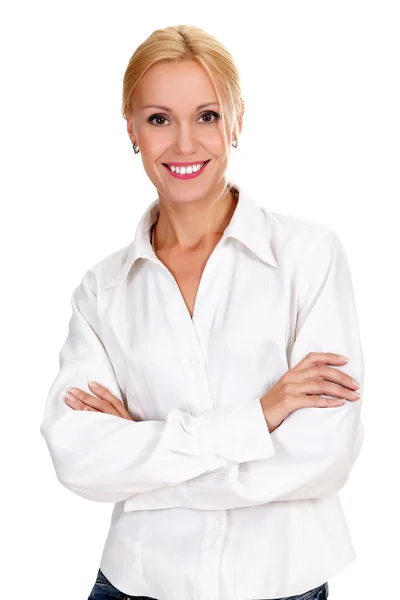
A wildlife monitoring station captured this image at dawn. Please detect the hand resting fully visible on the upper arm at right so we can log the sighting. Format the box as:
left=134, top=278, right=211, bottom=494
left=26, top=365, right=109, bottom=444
left=260, top=352, right=359, bottom=433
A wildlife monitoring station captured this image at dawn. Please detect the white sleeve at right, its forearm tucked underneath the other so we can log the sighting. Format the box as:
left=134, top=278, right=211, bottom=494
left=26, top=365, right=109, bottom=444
left=124, top=231, right=364, bottom=510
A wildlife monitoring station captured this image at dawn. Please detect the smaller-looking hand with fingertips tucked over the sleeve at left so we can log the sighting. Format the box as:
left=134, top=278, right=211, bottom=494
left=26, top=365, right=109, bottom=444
left=65, top=381, right=133, bottom=421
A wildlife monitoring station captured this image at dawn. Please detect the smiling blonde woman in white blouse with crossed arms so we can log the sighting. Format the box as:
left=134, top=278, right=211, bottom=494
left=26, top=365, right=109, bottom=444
left=41, top=25, right=364, bottom=600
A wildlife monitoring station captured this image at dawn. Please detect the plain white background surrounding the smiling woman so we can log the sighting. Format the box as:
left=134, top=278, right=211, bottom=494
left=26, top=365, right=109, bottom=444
left=0, top=0, right=400, bottom=600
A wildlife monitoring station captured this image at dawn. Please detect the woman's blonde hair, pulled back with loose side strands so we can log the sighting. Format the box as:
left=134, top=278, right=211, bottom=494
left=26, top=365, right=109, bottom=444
left=121, top=25, right=244, bottom=169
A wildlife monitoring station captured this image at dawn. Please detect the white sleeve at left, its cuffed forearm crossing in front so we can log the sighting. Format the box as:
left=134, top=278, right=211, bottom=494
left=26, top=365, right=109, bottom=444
left=40, top=270, right=275, bottom=502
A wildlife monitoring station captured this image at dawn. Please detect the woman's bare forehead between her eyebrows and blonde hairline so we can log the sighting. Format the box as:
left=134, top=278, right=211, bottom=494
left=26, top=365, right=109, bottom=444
left=132, top=61, right=218, bottom=108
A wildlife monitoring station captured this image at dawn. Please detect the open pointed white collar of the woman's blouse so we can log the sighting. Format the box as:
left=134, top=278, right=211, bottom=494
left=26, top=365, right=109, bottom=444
left=102, top=183, right=278, bottom=289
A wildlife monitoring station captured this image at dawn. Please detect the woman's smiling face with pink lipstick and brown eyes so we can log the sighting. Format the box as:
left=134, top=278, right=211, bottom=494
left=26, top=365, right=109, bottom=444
left=127, top=61, right=241, bottom=203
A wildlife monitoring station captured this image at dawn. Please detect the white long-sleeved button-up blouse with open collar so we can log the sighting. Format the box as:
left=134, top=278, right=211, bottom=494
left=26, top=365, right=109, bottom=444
left=40, top=184, right=364, bottom=600
